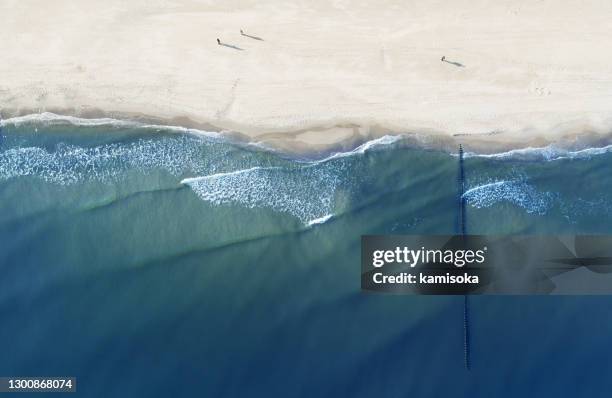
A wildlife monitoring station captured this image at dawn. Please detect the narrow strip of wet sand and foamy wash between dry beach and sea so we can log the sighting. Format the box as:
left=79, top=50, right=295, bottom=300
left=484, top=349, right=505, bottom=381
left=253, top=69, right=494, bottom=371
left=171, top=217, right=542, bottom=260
left=0, top=110, right=612, bottom=161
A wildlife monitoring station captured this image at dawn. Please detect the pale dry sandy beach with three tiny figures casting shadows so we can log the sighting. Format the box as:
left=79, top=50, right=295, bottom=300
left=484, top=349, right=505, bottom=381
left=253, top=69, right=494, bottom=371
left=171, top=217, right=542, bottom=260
left=0, top=0, right=612, bottom=151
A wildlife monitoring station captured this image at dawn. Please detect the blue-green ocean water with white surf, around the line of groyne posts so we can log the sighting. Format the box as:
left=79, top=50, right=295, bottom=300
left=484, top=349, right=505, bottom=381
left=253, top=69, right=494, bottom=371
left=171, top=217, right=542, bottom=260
left=0, top=114, right=612, bottom=397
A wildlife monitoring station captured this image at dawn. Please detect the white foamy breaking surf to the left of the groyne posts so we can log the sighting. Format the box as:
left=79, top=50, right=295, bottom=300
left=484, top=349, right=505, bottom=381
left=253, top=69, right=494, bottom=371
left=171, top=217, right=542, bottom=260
left=0, top=113, right=401, bottom=226
